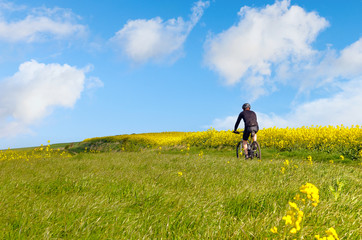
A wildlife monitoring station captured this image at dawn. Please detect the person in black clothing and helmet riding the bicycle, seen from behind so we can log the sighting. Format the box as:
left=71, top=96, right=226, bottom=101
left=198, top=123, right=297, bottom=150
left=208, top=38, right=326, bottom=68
left=233, top=103, right=259, bottom=159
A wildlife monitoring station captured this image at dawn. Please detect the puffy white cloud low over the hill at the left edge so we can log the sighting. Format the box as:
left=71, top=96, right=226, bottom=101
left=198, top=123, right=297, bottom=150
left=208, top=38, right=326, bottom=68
left=0, top=60, right=100, bottom=137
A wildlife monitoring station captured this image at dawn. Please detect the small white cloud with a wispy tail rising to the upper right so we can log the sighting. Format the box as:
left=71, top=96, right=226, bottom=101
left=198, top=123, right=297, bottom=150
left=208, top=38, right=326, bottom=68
left=111, top=0, right=209, bottom=63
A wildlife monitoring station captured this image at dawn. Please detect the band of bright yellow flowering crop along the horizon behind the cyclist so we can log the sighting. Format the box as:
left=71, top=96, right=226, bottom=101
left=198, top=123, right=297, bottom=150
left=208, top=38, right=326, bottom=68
left=84, top=125, right=362, bottom=159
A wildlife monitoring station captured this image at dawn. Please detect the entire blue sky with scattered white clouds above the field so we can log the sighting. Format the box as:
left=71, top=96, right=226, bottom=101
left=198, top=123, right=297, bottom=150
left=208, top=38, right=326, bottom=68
left=0, top=0, right=362, bottom=149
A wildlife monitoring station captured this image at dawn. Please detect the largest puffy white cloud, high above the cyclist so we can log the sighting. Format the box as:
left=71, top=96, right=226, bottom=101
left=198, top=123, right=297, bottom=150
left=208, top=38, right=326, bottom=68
left=205, top=0, right=328, bottom=95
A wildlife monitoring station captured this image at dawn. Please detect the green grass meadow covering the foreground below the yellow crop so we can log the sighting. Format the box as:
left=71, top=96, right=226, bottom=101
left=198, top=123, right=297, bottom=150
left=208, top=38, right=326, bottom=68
left=0, top=149, right=362, bottom=239
